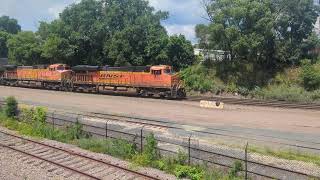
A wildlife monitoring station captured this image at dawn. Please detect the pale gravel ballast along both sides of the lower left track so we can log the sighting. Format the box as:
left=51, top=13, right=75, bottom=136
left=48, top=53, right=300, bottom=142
left=0, top=127, right=176, bottom=180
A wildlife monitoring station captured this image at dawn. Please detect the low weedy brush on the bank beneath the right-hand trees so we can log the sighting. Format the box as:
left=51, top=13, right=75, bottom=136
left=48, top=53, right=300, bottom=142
left=181, top=63, right=320, bottom=103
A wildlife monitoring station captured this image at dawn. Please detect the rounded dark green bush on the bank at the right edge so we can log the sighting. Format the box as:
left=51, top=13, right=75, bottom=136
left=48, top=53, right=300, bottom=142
left=301, top=63, right=320, bottom=91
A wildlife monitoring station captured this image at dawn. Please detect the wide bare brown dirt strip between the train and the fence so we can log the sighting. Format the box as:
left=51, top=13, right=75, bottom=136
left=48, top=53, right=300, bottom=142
left=0, top=86, right=320, bottom=145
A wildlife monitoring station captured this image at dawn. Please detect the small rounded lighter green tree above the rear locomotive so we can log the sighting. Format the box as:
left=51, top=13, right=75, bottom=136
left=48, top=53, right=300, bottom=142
left=7, top=31, right=42, bottom=65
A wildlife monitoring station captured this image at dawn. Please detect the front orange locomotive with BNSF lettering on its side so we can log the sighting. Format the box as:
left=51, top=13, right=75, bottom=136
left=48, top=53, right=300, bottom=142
left=72, top=66, right=185, bottom=98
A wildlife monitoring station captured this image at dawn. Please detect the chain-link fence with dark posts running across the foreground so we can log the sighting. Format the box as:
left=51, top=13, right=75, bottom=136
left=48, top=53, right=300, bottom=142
left=43, top=111, right=320, bottom=180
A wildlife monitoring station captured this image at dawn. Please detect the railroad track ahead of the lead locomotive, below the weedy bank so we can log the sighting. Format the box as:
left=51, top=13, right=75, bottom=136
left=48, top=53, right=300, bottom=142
left=187, top=96, right=320, bottom=110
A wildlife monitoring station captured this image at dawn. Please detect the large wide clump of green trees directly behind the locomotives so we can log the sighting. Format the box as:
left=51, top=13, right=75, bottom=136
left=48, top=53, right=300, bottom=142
left=37, top=0, right=193, bottom=67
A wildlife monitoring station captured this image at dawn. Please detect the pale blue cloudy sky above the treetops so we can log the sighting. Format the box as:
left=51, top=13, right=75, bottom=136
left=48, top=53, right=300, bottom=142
left=0, top=0, right=207, bottom=43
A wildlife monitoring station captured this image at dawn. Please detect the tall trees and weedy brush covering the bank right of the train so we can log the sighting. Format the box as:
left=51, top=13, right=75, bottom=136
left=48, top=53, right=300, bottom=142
left=182, top=0, right=320, bottom=102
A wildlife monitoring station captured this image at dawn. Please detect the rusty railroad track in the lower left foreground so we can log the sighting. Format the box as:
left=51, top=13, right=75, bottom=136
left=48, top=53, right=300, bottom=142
left=0, top=131, right=159, bottom=180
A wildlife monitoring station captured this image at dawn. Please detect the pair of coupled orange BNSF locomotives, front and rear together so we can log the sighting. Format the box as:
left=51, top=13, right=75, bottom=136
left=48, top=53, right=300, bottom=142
left=0, top=64, right=186, bottom=98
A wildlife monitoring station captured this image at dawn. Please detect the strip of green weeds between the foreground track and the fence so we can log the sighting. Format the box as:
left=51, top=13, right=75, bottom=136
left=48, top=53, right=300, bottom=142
left=0, top=108, right=246, bottom=180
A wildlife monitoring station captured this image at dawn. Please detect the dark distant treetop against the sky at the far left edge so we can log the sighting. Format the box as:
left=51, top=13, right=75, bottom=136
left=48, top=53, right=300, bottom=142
left=0, top=16, right=21, bottom=34
